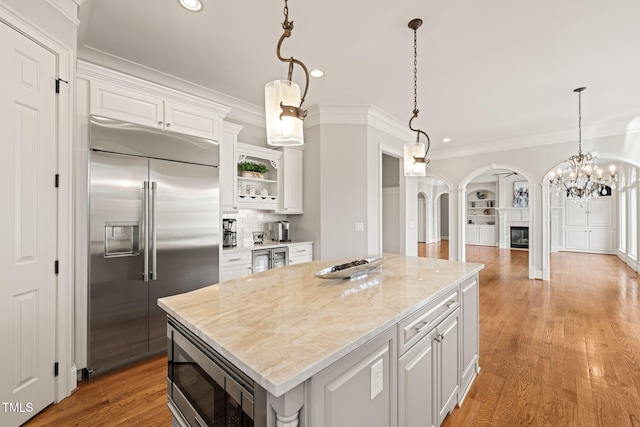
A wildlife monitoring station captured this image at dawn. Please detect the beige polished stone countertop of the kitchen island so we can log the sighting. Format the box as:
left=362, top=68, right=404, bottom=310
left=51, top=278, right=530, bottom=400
left=158, top=254, right=484, bottom=396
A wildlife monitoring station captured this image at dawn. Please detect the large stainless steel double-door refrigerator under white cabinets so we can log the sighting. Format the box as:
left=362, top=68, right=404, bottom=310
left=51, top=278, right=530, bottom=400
left=85, top=117, right=220, bottom=377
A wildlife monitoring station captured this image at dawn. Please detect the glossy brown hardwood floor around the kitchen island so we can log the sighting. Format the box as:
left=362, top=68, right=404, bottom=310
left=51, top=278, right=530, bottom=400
left=27, top=247, right=640, bottom=427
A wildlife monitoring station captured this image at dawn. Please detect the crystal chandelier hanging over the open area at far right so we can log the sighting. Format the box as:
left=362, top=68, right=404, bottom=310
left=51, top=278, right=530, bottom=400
left=549, top=87, right=618, bottom=203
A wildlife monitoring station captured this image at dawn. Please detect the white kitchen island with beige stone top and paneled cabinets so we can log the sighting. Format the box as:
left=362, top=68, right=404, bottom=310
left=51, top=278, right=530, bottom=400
left=158, top=254, right=483, bottom=427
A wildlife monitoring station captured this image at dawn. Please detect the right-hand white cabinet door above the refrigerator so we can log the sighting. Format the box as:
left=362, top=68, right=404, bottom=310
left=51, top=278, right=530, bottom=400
left=164, top=101, right=222, bottom=141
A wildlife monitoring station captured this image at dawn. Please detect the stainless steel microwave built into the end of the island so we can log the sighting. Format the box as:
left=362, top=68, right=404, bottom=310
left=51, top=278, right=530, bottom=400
left=167, top=317, right=267, bottom=427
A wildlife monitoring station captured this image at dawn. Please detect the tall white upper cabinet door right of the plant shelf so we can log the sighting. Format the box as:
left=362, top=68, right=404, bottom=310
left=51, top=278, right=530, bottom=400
left=279, top=147, right=304, bottom=214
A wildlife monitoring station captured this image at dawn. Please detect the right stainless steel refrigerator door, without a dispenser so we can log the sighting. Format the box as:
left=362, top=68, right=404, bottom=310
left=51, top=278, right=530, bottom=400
left=149, top=160, right=220, bottom=352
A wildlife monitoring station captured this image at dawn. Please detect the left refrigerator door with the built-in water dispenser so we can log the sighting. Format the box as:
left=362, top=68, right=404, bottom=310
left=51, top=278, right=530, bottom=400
left=88, top=152, right=148, bottom=372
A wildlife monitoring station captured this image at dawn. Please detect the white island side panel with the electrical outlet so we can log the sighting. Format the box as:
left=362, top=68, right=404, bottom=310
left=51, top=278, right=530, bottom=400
left=308, top=326, right=397, bottom=427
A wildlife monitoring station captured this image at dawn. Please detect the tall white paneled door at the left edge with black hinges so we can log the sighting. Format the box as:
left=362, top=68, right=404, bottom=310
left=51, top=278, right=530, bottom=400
left=0, top=21, right=57, bottom=426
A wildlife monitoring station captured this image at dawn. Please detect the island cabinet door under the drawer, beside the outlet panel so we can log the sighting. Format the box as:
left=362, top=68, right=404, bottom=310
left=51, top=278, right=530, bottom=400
left=398, top=330, right=436, bottom=427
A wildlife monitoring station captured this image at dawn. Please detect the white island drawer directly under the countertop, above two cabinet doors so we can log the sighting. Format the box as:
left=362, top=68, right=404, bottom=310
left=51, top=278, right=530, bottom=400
left=398, top=287, right=460, bottom=355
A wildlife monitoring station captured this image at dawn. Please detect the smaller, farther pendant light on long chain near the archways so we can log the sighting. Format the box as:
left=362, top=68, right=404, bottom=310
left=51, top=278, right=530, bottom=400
left=404, top=19, right=431, bottom=176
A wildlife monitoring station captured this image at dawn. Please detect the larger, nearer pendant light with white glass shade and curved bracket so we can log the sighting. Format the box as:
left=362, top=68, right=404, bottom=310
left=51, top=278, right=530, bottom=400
left=264, top=0, right=309, bottom=146
